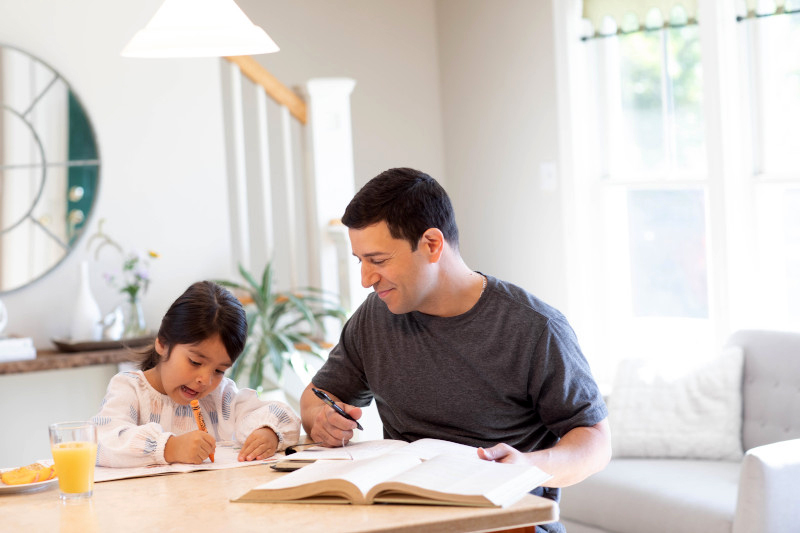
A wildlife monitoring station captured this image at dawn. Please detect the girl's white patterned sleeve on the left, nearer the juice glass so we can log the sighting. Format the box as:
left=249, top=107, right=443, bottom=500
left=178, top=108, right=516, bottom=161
left=92, top=373, right=172, bottom=468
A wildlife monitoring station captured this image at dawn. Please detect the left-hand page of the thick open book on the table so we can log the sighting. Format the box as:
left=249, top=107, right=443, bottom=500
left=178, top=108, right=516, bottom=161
left=253, top=448, right=420, bottom=503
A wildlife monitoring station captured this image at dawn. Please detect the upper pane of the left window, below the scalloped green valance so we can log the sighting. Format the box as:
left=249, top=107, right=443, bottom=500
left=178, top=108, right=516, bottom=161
left=608, top=26, right=705, bottom=180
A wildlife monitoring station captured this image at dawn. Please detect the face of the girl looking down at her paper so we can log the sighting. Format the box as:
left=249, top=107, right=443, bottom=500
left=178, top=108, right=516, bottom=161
left=148, top=334, right=231, bottom=405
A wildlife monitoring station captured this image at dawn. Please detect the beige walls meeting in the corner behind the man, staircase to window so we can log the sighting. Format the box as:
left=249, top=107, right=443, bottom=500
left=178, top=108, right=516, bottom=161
left=244, top=0, right=567, bottom=311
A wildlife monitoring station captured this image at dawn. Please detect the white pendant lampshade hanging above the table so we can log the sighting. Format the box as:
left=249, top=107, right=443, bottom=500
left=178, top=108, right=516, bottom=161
left=122, top=0, right=280, bottom=57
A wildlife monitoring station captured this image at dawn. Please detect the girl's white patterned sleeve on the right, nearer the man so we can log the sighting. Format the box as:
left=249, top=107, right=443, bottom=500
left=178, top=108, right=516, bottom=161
left=222, top=381, right=300, bottom=451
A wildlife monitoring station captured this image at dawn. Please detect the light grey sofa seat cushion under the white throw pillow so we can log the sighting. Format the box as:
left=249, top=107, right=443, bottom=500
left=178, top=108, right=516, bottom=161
left=560, top=459, right=739, bottom=533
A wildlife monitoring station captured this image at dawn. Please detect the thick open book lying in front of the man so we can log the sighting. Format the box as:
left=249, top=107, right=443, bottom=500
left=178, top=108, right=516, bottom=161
left=234, top=439, right=551, bottom=507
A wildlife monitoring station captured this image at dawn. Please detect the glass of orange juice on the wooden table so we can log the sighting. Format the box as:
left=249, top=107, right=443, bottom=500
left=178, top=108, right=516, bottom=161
left=50, top=422, right=97, bottom=500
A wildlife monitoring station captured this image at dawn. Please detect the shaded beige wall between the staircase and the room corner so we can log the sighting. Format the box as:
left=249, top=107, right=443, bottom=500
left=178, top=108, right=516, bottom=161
left=237, top=0, right=444, bottom=189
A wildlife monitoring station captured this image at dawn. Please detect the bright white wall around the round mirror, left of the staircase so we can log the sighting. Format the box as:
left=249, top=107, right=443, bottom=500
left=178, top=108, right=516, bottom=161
left=0, top=0, right=230, bottom=349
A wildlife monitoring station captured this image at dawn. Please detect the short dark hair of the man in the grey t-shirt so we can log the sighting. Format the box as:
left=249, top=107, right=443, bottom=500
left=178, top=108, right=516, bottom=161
left=342, top=168, right=458, bottom=251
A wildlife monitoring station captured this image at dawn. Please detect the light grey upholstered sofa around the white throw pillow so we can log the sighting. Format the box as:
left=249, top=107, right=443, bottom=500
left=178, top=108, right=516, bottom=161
left=560, top=330, right=800, bottom=533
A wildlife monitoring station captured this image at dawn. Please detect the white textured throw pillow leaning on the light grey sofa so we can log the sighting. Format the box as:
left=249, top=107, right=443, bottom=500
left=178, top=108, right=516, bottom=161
left=608, top=346, right=743, bottom=460
